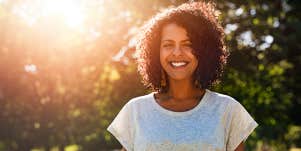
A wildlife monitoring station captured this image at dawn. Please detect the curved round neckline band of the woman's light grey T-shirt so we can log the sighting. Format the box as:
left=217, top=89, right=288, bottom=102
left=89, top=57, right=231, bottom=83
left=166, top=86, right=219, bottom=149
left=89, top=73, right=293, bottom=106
left=150, top=89, right=210, bottom=116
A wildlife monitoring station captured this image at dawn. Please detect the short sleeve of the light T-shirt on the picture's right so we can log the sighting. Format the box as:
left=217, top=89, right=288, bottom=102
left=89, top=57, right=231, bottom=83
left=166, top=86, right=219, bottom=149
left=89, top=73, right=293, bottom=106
left=227, top=101, right=258, bottom=151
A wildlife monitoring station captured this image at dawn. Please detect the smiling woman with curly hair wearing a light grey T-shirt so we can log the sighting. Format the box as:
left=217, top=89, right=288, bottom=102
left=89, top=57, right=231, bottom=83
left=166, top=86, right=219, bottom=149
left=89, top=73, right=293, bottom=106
left=107, top=2, right=258, bottom=151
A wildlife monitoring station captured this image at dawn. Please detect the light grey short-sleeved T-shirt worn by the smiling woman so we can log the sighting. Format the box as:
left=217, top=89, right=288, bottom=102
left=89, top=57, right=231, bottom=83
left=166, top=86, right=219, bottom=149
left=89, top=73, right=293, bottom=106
left=107, top=89, right=258, bottom=151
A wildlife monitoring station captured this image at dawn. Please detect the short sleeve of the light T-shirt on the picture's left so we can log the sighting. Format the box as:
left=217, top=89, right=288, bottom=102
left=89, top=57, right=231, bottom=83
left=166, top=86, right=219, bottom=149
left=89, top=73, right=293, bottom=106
left=107, top=103, right=134, bottom=151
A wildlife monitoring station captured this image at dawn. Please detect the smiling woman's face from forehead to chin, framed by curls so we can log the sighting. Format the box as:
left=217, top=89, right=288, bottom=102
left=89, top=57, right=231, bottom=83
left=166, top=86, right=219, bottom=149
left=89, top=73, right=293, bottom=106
left=160, top=23, right=198, bottom=80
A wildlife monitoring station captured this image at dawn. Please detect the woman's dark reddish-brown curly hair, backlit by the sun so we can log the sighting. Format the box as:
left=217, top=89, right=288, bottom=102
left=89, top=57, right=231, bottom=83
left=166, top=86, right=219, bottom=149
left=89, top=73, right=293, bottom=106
left=136, top=2, right=228, bottom=92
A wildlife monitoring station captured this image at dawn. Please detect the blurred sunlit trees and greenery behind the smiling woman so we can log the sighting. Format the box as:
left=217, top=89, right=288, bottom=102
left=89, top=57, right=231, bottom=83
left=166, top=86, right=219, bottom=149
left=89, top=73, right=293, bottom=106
left=0, top=0, right=301, bottom=151
